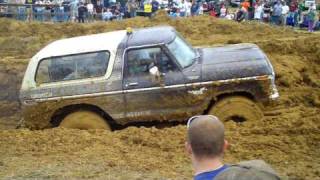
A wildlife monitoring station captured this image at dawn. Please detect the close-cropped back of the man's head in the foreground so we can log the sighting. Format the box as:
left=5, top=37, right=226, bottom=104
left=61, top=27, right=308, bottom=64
left=187, top=115, right=224, bottom=158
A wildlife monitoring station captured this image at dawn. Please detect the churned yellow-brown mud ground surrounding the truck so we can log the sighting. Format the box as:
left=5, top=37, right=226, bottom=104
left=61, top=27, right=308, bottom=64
left=0, top=11, right=320, bottom=179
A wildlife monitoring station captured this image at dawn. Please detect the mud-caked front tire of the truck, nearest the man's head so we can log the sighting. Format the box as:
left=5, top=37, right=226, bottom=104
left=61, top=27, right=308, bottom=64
left=209, top=96, right=263, bottom=122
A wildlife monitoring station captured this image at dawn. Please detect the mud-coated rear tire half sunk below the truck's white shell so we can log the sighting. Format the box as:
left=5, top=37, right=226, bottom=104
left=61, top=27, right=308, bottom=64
left=59, top=111, right=111, bottom=130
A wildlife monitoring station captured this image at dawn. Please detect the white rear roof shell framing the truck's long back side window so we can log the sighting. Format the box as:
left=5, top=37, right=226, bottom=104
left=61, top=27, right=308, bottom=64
left=21, top=30, right=127, bottom=89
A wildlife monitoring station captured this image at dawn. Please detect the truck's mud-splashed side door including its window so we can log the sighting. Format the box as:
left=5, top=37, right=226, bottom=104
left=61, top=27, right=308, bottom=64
left=123, top=46, right=186, bottom=121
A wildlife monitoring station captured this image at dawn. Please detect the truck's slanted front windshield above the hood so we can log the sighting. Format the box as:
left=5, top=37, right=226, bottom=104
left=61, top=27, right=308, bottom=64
left=168, top=35, right=197, bottom=68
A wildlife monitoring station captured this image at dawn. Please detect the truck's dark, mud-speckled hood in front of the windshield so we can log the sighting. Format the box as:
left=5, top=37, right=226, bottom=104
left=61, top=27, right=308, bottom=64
left=199, top=44, right=274, bottom=81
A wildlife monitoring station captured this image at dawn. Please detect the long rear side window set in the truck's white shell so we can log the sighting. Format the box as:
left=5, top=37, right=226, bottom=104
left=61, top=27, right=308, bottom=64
left=36, top=51, right=110, bottom=84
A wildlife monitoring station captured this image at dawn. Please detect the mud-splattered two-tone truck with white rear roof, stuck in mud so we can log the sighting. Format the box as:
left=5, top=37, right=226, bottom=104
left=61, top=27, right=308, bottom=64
left=20, top=26, right=279, bottom=129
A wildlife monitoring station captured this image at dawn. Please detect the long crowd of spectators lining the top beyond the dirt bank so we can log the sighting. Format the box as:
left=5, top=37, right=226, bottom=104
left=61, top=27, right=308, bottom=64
left=0, top=0, right=320, bottom=32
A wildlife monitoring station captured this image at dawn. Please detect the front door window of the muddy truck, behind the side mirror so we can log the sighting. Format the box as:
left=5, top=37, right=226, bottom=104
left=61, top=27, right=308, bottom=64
left=127, top=47, right=177, bottom=77
